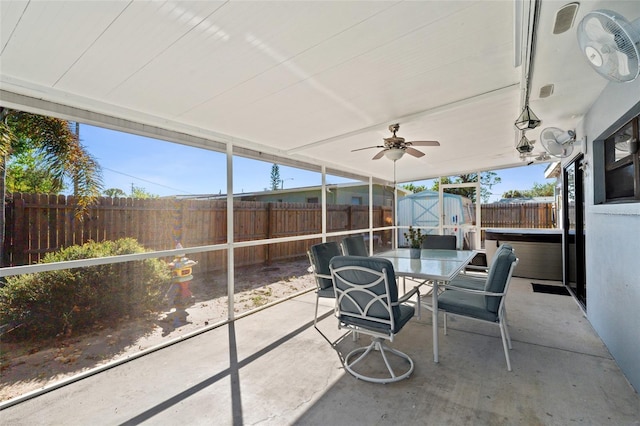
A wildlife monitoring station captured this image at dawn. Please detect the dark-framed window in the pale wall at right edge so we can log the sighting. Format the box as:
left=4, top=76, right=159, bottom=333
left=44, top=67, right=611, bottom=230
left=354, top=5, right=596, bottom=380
left=604, top=115, right=640, bottom=203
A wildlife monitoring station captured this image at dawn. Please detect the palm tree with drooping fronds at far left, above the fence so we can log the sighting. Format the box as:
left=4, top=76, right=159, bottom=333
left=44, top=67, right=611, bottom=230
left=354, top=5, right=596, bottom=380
left=0, top=107, right=102, bottom=261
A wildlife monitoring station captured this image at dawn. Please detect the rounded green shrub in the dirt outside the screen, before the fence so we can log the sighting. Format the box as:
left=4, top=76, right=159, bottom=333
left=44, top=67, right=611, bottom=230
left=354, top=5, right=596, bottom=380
left=0, top=238, right=171, bottom=339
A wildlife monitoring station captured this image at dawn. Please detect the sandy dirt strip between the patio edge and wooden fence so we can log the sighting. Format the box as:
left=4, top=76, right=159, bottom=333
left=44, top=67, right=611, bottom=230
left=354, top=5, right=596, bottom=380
left=0, top=260, right=315, bottom=401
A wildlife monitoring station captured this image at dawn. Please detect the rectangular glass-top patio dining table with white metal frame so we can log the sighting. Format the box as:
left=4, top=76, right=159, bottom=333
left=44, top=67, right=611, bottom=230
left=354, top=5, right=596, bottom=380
left=376, top=249, right=476, bottom=362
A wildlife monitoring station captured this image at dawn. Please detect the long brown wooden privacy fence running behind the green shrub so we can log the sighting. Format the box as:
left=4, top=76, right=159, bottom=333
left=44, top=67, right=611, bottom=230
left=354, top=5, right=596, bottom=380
left=3, top=194, right=392, bottom=271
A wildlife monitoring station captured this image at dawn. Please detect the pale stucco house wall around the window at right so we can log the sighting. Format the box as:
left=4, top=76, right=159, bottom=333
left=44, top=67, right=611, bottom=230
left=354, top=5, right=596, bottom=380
left=577, top=78, right=640, bottom=391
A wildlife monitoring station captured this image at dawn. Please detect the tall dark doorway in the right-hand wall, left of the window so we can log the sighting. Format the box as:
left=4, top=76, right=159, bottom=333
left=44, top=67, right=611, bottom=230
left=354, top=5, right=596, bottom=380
left=562, top=155, right=587, bottom=310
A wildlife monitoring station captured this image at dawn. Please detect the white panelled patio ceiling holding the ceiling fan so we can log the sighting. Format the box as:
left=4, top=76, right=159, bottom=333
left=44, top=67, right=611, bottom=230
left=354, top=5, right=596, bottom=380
left=0, top=0, right=640, bottom=181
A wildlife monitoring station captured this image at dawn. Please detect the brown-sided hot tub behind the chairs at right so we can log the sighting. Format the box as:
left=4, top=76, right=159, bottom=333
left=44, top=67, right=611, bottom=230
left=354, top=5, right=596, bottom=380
left=485, top=228, right=562, bottom=281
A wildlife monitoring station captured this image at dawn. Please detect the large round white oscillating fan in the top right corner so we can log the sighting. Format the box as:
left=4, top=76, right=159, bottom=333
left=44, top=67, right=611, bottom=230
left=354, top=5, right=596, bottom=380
left=577, top=9, right=640, bottom=83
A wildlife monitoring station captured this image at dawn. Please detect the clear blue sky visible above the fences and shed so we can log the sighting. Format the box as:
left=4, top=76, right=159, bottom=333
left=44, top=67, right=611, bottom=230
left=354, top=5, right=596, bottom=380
left=80, top=125, right=547, bottom=201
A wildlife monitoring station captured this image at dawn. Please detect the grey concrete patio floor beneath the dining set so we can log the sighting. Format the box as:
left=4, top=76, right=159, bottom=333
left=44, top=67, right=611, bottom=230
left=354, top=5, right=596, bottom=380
left=0, top=278, right=640, bottom=425
